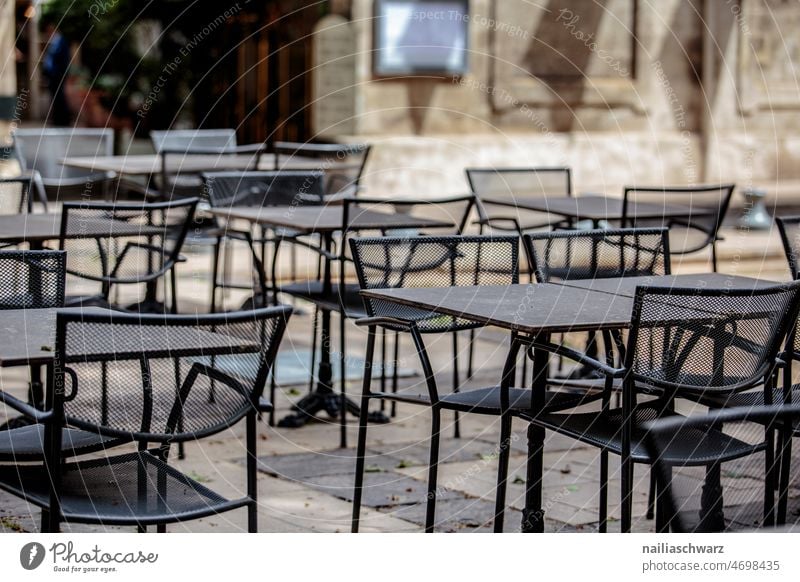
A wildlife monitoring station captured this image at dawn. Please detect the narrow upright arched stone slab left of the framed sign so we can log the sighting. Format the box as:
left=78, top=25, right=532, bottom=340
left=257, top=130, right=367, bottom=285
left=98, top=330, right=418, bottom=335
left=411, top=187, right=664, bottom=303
left=311, top=15, right=356, bottom=137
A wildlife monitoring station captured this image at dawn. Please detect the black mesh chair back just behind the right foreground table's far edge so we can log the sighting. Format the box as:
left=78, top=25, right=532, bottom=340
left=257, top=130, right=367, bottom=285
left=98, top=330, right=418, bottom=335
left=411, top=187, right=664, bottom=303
left=523, top=228, right=670, bottom=283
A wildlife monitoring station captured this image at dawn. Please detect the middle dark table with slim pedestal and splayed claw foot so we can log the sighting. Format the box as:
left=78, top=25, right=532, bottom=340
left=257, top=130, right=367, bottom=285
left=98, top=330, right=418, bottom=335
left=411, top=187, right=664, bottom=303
left=209, top=204, right=453, bottom=447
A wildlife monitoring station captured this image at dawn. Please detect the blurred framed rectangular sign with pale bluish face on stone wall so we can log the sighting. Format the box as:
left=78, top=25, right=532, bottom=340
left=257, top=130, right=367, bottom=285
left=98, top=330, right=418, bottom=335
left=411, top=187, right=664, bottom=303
left=374, top=0, right=470, bottom=76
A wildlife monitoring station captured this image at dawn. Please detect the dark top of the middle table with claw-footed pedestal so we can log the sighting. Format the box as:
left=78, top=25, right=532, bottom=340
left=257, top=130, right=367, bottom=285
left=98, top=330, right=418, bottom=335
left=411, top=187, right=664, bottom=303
left=208, top=205, right=453, bottom=233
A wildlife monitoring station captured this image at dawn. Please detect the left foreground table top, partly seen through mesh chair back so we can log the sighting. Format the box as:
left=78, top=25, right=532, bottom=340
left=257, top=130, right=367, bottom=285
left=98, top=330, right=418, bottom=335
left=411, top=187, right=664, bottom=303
left=0, top=307, right=259, bottom=367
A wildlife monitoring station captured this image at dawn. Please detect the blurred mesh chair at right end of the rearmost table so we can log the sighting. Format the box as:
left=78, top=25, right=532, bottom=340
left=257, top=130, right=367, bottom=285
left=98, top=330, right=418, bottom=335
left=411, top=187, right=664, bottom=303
left=273, top=141, right=372, bottom=196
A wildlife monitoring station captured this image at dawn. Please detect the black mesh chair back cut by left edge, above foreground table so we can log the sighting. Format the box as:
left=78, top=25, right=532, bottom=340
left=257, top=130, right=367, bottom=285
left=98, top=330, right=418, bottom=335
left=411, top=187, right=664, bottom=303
left=0, top=250, right=66, bottom=310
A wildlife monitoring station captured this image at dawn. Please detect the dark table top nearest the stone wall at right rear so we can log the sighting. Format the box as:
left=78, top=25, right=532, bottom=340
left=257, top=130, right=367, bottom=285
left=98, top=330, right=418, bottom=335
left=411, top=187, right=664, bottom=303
left=481, top=194, right=711, bottom=221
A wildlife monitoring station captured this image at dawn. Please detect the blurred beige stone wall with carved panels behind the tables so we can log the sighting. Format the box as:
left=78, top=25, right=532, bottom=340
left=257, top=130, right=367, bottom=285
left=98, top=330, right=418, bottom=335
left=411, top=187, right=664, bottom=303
left=318, top=0, right=800, bottom=210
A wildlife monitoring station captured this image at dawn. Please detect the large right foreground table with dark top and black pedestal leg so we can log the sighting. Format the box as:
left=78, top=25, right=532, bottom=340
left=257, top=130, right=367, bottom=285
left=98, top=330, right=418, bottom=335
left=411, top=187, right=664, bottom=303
left=362, top=273, right=774, bottom=532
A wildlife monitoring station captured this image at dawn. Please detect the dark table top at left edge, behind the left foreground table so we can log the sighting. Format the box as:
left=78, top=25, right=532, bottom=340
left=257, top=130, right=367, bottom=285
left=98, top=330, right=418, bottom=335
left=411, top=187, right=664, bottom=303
left=0, top=213, right=164, bottom=243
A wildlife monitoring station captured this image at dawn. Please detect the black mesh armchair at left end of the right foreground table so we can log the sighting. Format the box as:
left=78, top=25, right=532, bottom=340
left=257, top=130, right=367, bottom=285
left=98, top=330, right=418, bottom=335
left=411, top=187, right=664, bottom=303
left=350, top=235, right=599, bottom=532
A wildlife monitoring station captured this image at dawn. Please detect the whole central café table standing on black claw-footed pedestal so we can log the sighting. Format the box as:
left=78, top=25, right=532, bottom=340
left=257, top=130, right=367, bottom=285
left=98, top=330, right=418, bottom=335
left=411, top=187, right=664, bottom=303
left=203, top=201, right=460, bottom=447
